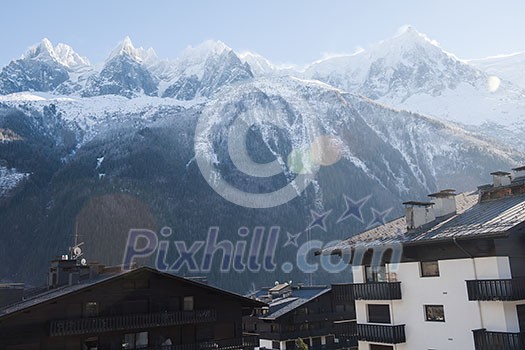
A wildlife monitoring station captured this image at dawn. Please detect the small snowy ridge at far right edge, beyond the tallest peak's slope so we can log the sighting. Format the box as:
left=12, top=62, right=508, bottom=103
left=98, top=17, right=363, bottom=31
left=468, top=52, right=525, bottom=89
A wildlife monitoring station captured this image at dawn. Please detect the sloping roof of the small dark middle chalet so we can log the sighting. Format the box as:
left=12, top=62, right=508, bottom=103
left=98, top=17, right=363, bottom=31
left=252, top=286, right=331, bottom=320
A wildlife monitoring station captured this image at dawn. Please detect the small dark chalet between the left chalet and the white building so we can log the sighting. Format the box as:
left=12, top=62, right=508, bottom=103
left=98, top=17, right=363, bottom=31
left=243, top=282, right=357, bottom=350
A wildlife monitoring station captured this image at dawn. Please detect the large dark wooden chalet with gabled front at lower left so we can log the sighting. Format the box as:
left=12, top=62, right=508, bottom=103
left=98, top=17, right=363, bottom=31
left=0, top=268, right=264, bottom=350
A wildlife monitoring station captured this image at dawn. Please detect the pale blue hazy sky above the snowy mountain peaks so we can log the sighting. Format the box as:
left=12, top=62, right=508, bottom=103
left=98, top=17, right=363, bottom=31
left=0, top=0, right=525, bottom=66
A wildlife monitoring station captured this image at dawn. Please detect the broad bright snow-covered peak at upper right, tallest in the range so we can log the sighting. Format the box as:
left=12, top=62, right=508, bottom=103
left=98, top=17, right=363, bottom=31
left=304, top=27, right=525, bottom=126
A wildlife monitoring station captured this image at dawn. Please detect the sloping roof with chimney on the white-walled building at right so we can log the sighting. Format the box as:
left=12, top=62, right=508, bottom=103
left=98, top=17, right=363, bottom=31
left=321, top=192, right=525, bottom=254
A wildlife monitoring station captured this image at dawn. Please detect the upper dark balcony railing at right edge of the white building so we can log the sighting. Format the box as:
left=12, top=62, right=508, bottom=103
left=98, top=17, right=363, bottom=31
left=467, top=278, right=525, bottom=301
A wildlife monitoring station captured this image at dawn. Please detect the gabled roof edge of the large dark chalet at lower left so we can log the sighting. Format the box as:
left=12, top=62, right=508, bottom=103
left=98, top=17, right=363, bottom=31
left=0, top=266, right=266, bottom=320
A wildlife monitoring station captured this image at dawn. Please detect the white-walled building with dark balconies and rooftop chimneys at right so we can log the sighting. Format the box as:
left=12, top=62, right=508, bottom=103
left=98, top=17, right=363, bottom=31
left=317, top=167, right=525, bottom=350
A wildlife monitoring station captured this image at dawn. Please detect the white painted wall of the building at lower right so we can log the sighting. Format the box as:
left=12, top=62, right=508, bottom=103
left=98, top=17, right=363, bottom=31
left=352, top=257, right=519, bottom=350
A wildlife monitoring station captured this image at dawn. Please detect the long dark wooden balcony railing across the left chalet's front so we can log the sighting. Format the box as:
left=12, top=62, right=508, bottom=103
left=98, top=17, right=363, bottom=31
left=49, top=310, right=217, bottom=337
